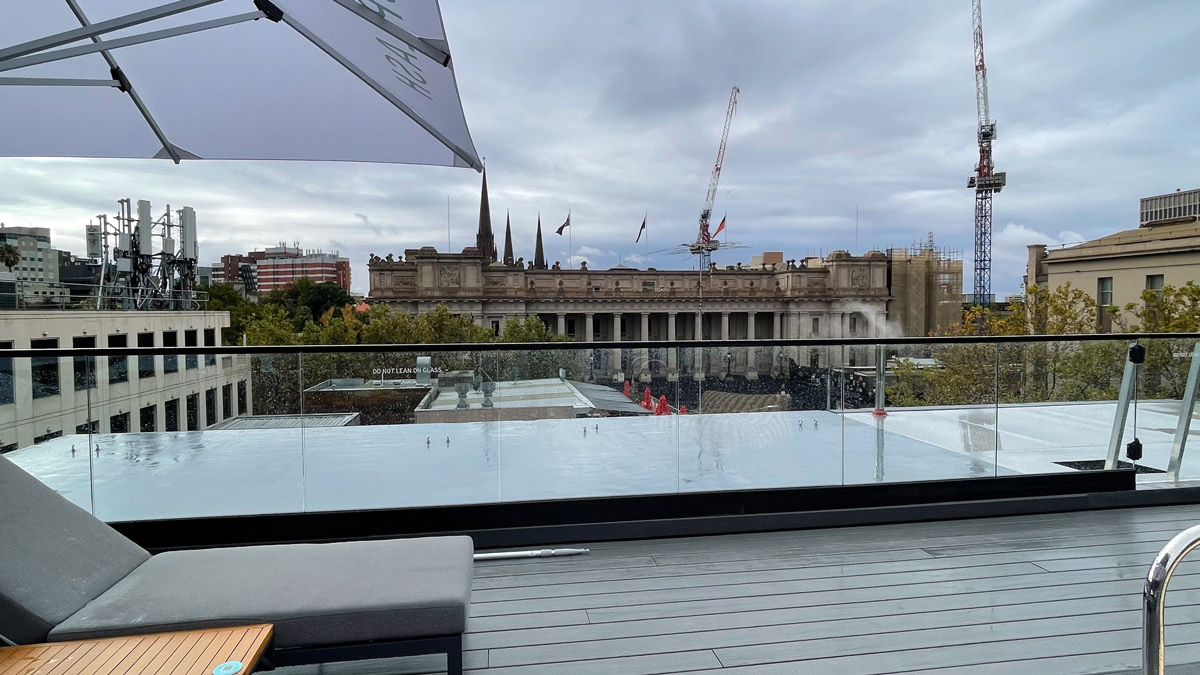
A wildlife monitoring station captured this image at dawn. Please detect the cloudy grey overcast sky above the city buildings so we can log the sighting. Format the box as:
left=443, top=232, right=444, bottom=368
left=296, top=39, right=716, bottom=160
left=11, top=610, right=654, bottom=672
left=0, top=0, right=1200, bottom=295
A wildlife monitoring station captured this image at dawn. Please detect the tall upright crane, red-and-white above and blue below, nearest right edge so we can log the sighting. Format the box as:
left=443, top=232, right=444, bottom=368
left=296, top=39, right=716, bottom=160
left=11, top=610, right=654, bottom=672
left=967, top=0, right=1007, bottom=306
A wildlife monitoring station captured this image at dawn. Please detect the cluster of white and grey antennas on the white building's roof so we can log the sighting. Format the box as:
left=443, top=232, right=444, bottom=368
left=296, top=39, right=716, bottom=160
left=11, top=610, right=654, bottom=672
left=86, top=199, right=199, bottom=310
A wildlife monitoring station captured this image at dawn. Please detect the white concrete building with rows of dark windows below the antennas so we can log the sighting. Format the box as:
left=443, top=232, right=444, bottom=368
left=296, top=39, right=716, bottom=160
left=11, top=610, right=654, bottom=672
left=0, top=311, right=253, bottom=453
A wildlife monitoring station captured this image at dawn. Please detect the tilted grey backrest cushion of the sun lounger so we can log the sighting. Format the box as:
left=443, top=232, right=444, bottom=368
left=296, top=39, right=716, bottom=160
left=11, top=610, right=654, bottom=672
left=0, top=456, right=150, bottom=644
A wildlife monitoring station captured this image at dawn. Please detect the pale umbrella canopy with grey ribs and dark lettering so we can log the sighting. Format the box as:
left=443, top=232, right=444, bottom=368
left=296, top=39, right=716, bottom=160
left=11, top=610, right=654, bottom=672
left=0, top=0, right=482, bottom=169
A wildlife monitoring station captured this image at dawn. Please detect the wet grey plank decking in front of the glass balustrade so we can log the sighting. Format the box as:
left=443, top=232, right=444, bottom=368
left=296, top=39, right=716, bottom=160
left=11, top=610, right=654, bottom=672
left=278, top=506, right=1200, bottom=675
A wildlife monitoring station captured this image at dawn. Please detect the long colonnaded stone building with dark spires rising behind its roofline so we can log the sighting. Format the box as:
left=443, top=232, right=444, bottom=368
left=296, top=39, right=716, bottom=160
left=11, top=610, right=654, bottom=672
left=368, top=177, right=961, bottom=376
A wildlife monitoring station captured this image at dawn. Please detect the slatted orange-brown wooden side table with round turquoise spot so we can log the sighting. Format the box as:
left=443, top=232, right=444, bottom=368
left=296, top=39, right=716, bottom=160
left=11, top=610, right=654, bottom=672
left=0, top=623, right=272, bottom=675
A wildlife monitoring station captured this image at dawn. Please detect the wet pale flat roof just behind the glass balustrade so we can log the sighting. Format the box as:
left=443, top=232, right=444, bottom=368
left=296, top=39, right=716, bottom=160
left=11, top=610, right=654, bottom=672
left=6, top=400, right=1200, bottom=521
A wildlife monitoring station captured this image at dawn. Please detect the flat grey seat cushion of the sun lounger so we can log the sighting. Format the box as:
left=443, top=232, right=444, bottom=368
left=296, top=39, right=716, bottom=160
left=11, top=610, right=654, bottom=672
left=50, top=537, right=474, bottom=647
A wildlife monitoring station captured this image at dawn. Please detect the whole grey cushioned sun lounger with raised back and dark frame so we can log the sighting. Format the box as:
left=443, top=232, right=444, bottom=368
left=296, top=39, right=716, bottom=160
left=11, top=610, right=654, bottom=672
left=0, top=458, right=473, bottom=674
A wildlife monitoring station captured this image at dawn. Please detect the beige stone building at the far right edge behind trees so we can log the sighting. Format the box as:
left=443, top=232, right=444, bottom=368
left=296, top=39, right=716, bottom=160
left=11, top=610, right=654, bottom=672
left=1025, top=190, right=1200, bottom=330
